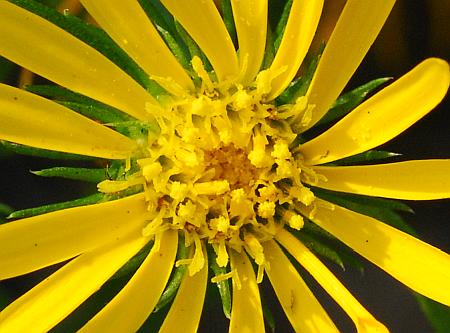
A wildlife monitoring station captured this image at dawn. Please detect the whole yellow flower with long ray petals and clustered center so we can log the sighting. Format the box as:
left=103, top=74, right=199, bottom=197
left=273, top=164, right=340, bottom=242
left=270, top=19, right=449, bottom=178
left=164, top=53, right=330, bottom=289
left=0, top=0, right=450, bottom=332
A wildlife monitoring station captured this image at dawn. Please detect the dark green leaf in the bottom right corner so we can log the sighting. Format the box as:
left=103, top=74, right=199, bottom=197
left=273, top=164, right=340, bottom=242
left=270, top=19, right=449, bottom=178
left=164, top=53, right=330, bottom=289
left=413, top=294, right=450, bottom=333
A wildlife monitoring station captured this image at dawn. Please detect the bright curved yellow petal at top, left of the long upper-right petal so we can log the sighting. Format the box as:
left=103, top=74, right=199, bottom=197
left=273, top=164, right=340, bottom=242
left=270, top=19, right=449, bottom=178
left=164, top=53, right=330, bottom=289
left=267, top=0, right=323, bottom=100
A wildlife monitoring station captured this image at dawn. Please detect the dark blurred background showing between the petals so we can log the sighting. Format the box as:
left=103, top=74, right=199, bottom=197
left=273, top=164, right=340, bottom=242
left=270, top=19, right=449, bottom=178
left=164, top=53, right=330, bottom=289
left=0, top=0, right=450, bottom=333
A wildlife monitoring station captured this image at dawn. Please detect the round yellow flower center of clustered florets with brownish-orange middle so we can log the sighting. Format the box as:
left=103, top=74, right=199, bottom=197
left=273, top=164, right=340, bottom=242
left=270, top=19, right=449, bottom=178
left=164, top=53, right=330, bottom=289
left=99, top=58, right=320, bottom=278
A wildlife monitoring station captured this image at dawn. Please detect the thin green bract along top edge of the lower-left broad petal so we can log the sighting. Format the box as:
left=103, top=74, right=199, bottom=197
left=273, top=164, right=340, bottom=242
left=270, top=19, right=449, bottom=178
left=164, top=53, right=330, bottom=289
left=8, top=193, right=105, bottom=219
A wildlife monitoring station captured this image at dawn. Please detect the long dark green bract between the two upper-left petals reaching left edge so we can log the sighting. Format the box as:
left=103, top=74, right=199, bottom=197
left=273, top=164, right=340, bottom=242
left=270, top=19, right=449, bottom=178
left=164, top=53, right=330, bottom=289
left=25, top=85, right=133, bottom=123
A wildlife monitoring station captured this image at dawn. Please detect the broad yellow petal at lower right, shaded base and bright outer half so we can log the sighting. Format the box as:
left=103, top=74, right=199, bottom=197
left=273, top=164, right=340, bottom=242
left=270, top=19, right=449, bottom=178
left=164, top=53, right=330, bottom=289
left=298, top=199, right=450, bottom=306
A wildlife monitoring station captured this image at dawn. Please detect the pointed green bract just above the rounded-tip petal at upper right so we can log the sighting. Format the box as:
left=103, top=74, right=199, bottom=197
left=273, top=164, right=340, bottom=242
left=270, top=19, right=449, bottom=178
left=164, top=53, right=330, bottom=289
left=316, top=77, right=392, bottom=126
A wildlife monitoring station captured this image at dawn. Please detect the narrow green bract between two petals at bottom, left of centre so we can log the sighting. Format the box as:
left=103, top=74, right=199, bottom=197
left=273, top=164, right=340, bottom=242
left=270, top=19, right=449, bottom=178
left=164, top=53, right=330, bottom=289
left=153, top=237, right=189, bottom=312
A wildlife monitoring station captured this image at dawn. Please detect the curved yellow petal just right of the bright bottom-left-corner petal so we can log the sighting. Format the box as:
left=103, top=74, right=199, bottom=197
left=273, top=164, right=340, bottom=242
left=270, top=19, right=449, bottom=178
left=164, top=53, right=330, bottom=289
left=79, top=230, right=178, bottom=333
